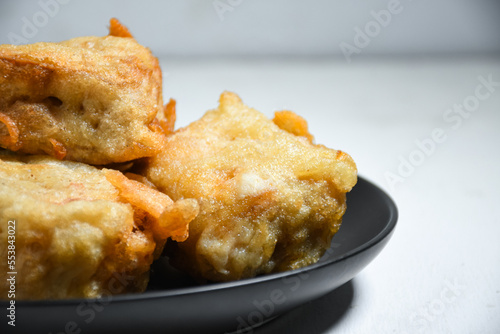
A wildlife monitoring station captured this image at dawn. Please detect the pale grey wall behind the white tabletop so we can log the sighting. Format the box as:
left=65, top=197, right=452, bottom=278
left=0, top=0, right=500, bottom=56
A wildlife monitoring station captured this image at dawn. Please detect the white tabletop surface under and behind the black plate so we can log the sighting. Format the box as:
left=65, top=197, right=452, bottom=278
left=161, top=57, right=500, bottom=334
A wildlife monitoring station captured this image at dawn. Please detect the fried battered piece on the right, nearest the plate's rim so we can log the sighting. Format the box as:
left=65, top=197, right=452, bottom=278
left=144, top=92, right=357, bottom=281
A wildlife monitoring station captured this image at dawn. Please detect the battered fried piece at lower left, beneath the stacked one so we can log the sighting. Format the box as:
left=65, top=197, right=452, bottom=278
left=0, top=152, right=198, bottom=299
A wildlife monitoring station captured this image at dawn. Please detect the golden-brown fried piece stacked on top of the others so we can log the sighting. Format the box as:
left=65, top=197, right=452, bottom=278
left=0, top=19, right=168, bottom=165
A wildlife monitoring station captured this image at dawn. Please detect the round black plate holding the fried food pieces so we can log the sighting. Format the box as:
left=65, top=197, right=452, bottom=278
left=0, top=177, right=397, bottom=334
